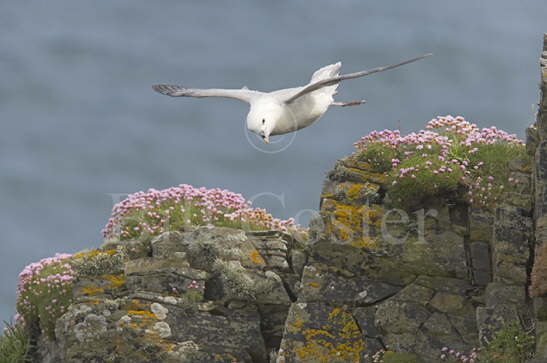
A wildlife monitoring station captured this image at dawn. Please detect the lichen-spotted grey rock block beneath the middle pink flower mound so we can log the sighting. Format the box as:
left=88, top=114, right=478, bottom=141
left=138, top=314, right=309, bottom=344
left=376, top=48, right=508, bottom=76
left=37, top=227, right=305, bottom=362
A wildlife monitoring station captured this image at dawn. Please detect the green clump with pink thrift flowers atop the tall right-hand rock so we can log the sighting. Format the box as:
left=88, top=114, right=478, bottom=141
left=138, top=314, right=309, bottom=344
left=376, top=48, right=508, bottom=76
left=354, top=116, right=527, bottom=209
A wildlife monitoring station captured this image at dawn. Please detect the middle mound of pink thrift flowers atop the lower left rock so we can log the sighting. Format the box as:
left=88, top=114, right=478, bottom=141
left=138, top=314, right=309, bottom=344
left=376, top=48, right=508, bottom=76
left=103, top=184, right=296, bottom=239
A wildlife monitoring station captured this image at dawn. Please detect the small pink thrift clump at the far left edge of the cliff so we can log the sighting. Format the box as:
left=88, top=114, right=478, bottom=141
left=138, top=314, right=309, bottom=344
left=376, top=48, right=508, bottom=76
left=16, top=254, right=75, bottom=336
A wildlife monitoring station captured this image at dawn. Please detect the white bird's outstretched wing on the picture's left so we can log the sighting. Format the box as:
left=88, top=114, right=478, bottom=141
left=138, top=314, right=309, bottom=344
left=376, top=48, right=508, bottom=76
left=152, top=84, right=262, bottom=103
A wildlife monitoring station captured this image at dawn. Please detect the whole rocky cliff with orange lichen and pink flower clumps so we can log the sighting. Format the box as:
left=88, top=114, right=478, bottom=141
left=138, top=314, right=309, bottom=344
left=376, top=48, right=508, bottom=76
left=0, top=34, right=547, bottom=363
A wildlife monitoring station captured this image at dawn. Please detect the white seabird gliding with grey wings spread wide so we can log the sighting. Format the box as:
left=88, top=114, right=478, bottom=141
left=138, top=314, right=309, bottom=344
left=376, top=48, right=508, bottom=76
left=152, top=53, right=432, bottom=143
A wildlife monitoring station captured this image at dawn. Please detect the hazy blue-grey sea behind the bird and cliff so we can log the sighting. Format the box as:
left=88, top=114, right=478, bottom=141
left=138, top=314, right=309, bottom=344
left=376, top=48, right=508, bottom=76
left=0, top=0, right=547, bottom=320
